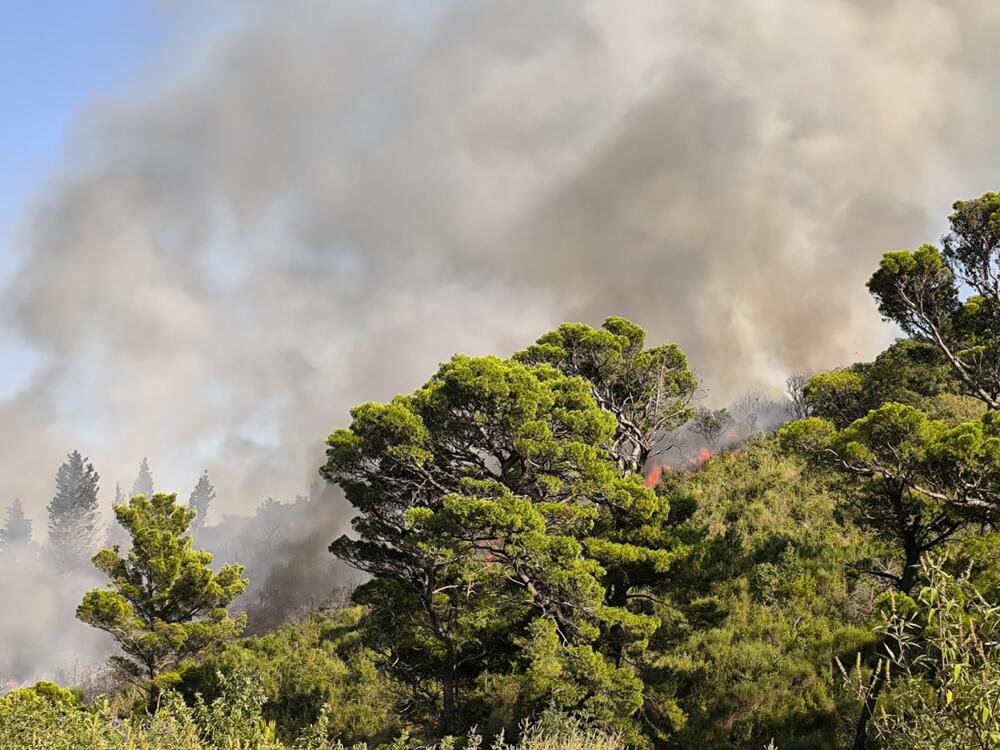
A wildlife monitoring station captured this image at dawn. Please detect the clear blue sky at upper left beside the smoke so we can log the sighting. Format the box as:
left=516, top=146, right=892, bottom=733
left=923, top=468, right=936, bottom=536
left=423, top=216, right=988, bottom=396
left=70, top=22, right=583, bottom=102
left=0, top=0, right=240, bottom=399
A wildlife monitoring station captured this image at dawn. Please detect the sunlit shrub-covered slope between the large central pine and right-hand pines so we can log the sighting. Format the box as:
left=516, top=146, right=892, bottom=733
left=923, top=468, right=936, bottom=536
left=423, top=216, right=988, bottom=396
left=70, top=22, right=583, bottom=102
left=653, top=438, right=874, bottom=750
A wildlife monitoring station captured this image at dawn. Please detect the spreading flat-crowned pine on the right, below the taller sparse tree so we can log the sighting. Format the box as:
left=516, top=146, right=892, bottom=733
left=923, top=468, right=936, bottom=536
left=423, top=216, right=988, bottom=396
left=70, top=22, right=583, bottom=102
left=779, top=403, right=1000, bottom=750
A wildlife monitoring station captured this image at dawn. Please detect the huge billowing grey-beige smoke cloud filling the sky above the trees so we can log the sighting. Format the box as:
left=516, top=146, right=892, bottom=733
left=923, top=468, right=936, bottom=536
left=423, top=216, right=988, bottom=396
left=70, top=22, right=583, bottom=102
left=0, top=0, right=1000, bottom=684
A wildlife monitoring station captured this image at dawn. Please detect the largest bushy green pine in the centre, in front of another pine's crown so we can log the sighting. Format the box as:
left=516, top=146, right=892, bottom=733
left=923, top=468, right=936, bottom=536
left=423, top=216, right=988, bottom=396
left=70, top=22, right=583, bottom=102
left=323, top=342, right=684, bottom=741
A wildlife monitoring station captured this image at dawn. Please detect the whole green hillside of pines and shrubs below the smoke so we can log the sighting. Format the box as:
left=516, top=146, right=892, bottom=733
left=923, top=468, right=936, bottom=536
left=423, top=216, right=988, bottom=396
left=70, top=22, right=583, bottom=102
left=0, top=193, right=1000, bottom=750
